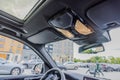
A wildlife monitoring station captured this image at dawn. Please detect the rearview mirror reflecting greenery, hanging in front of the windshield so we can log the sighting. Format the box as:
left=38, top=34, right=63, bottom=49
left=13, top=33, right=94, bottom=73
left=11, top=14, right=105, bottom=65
left=79, top=44, right=104, bottom=54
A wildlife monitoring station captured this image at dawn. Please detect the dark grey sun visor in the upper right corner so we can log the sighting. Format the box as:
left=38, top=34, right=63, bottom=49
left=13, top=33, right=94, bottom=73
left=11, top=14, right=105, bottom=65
left=87, top=0, right=120, bottom=30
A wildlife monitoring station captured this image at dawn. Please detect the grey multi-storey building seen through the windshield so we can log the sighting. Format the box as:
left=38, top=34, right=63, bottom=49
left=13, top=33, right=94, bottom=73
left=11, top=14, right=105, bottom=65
left=45, top=40, right=73, bottom=63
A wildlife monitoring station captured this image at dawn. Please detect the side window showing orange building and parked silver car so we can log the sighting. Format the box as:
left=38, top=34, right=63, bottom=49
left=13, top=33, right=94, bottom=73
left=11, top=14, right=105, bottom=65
left=0, top=35, right=44, bottom=75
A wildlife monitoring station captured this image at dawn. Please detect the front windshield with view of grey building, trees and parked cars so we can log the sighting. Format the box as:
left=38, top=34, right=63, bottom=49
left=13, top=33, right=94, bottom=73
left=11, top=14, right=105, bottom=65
left=45, top=28, right=120, bottom=80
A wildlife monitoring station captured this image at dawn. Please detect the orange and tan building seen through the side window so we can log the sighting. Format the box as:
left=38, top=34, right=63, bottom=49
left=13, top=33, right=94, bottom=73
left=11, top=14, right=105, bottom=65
left=0, top=35, right=23, bottom=61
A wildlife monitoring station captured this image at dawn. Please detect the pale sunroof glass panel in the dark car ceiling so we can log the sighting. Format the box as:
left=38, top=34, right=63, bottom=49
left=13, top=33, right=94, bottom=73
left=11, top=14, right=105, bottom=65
left=0, top=0, right=39, bottom=19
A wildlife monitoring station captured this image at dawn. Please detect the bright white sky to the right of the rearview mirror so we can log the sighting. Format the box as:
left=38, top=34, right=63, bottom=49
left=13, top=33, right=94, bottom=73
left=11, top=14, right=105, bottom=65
left=97, top=28, right=120, bottom=57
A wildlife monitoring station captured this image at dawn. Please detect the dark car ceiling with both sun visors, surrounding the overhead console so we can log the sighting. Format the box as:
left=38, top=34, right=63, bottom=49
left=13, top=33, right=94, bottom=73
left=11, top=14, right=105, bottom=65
left=1, top=0, right=117, bottom=44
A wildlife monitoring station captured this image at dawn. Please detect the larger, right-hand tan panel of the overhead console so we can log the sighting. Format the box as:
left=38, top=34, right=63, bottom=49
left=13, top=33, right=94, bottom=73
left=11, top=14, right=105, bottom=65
left=75, top=20, right=94, bottom=35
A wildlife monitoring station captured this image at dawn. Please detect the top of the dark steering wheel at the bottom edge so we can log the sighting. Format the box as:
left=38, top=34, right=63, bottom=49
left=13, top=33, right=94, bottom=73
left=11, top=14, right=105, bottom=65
left=40, top=68, right=66, bottom=80
